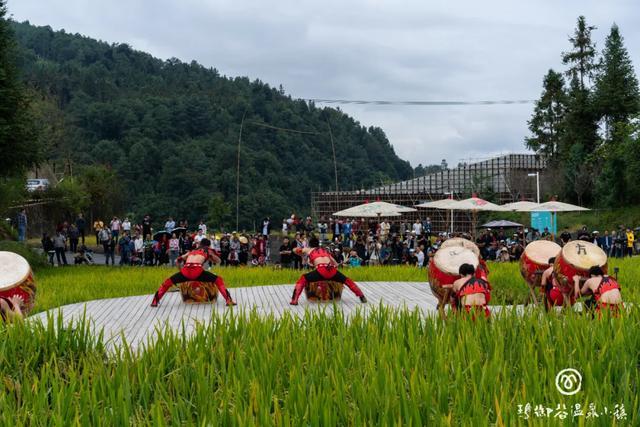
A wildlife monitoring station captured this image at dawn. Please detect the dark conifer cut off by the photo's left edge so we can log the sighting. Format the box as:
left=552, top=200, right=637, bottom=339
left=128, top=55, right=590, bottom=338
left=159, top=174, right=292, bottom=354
left=0, top=0, right=42, bottom=177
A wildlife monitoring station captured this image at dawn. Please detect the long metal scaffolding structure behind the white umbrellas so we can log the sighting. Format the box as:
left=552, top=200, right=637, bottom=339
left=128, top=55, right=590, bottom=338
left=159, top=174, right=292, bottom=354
left=311, top=154, right=546, bottom=232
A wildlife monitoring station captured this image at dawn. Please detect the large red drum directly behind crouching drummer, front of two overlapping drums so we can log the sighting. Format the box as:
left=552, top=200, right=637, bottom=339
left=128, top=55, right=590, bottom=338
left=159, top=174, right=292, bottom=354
left=429, top=246, right=480, bottom=303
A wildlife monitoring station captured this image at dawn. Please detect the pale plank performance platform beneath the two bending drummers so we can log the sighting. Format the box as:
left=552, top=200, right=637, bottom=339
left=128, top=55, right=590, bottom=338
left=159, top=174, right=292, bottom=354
left=30, top=282, right=438, bottom=348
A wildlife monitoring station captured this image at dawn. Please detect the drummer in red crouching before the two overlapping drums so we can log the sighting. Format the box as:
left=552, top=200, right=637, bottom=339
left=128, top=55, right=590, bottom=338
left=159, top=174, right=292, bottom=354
left=442, top=264, right=491, bottom=319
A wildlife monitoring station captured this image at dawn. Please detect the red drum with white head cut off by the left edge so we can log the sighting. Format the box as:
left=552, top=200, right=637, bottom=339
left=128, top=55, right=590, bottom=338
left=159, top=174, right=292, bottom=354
left=0, top=251, right=36, bottom=314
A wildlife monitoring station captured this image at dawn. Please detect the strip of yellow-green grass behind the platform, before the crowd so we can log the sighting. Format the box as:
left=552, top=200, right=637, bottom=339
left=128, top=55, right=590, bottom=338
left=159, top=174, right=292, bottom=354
left=33, top=258, right=640, bottom=313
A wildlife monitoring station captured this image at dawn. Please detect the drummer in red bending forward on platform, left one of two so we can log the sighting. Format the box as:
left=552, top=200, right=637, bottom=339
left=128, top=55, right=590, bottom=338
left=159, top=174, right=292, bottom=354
left=151, top=239, right=236, bottom=307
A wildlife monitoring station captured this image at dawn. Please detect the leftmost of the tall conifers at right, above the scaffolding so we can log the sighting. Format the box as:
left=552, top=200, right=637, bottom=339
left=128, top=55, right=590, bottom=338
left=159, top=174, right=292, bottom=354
left=525, top=70, right=567, bottom=160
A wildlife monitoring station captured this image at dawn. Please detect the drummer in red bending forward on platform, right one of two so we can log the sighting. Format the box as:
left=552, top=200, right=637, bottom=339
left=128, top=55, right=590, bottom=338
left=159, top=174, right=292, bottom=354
left=290, top=237, right=367, bottom=305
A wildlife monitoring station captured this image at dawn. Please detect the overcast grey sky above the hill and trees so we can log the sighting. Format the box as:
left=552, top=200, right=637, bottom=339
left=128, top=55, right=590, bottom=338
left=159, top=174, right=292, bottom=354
left=8, top=0, right=640, bottom=166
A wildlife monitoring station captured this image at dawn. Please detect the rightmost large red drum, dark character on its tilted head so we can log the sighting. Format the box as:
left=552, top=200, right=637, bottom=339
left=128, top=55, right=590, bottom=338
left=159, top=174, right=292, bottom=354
left=553, top=240, right=607, bottom=292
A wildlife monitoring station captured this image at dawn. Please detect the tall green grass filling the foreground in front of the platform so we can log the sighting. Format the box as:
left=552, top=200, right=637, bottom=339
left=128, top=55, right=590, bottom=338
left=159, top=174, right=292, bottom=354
left=0, top=309, right=640, bottom=426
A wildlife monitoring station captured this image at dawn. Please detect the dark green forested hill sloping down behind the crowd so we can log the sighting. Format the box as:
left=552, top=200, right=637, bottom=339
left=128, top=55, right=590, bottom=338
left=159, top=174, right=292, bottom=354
left=13, top=23, right=412, bottom=227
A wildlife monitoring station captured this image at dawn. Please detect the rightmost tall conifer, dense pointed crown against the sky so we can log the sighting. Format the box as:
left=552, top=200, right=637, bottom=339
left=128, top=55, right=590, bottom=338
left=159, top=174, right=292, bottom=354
left=595, top=24, right=640, bottom=141
